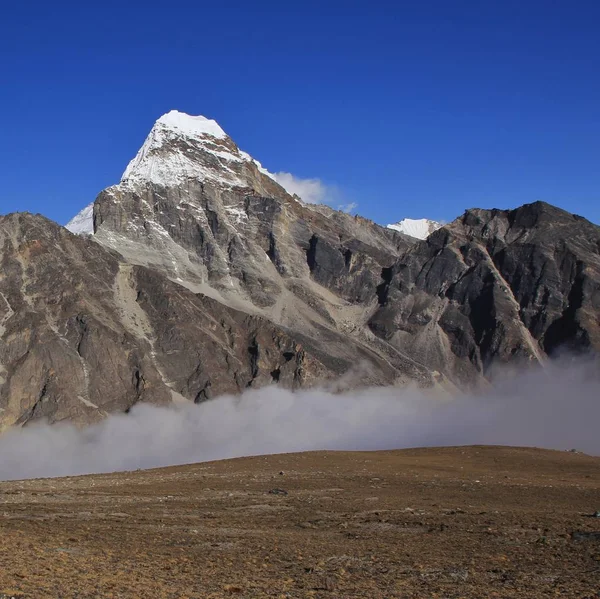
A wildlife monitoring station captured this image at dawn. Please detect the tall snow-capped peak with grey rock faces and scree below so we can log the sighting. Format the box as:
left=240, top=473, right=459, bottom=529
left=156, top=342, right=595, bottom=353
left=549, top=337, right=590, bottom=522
left=84, top=113, right=432, bottom=384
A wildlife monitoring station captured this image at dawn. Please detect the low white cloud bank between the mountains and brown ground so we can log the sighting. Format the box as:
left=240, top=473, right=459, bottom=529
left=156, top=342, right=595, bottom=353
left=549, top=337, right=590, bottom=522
left=0, top=364, right=600, bottom=480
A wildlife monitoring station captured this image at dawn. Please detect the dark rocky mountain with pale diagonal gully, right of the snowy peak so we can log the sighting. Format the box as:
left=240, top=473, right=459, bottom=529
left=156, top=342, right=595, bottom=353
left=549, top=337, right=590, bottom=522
left=370, top=202, right=600, bottom=386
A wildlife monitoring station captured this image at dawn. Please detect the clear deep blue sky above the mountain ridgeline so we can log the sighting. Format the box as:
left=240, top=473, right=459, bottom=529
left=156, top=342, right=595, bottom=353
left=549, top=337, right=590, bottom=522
left=0, top=0, right=600, bottom=223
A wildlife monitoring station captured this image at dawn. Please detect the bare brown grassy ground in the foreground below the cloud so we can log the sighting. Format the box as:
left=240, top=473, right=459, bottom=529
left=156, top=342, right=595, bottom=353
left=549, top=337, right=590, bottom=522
left=0, top=447, right=600, bottom=599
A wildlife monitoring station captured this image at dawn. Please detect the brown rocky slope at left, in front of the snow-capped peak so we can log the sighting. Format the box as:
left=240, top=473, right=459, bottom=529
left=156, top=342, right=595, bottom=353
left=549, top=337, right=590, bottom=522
left=0, top=213, right=408, bottom=427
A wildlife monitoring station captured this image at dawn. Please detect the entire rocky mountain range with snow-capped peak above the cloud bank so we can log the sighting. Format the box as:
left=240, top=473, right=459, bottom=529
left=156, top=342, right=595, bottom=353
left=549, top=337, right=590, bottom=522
left=0, top=112, right=600, bottom=427
